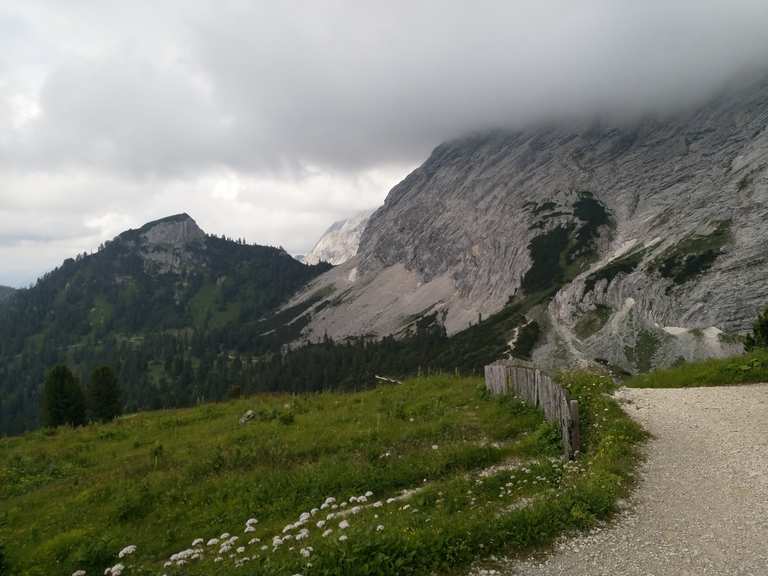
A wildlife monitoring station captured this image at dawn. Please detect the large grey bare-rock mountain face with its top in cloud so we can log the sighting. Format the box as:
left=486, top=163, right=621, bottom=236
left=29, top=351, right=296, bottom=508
left=286, top=82, right=768, bottom=372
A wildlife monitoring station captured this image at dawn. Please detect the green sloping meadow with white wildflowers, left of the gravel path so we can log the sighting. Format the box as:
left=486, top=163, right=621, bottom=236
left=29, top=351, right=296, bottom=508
left=0, top=374, right=643, bottom=576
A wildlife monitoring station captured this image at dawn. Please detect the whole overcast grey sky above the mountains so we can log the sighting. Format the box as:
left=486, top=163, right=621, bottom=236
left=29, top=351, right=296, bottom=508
left=0, top=0, right=768, bottom=286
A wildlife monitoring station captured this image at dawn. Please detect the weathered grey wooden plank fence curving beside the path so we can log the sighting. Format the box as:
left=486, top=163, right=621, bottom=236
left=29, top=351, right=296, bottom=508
left=485, top=359, right=581, bottom=458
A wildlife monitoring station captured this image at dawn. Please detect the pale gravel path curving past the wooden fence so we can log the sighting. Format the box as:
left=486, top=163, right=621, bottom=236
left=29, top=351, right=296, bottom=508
left=473, top=385, right=768, bottom=576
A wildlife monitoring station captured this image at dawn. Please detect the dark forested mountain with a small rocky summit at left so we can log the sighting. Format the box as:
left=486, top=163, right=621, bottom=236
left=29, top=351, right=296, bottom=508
left=0, top=214, right=330, bottom=433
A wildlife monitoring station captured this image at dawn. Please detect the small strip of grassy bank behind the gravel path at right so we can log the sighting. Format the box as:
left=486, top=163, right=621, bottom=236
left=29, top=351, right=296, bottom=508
left=625, top=350, right=768, bottom=388
